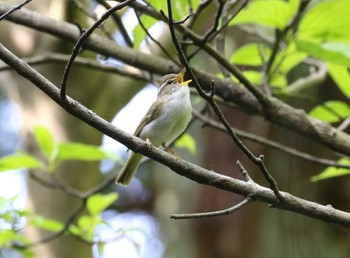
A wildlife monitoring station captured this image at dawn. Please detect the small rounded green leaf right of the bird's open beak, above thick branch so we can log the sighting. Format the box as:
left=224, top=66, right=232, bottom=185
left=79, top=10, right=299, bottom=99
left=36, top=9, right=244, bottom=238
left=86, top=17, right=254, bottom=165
left=230, top=43, right=271, bottom=66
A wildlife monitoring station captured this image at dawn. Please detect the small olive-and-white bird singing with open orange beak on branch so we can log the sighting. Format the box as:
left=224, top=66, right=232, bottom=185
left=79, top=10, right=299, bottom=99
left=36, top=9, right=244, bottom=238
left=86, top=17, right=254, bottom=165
left=115, top=68, right=192, bottom=185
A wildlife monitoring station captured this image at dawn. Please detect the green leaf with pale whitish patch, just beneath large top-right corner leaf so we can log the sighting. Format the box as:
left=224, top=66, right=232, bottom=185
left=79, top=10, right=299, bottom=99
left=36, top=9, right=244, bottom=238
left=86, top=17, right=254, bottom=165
left=296, top=40, right=350, bottom=66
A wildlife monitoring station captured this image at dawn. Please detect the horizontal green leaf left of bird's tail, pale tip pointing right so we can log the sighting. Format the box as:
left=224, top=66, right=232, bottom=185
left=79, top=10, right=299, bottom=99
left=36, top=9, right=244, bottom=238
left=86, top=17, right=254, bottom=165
left=57, top=142, right=118, bottom=161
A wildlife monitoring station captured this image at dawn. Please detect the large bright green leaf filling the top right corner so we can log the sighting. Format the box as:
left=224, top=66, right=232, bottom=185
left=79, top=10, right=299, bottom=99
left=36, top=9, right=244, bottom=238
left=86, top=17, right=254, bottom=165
left=297, top=0, right=350, bottom=42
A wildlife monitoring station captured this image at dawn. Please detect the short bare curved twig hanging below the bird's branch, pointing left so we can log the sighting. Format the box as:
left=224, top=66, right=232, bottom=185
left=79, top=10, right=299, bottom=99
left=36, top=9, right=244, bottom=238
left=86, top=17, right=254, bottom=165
left=170, top=197, right=252, bottom=219
